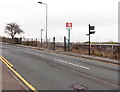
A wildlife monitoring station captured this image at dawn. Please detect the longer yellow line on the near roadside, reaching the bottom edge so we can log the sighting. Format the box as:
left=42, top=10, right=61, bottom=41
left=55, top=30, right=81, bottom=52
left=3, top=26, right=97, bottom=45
left=0, top=57, right=38, bottom=92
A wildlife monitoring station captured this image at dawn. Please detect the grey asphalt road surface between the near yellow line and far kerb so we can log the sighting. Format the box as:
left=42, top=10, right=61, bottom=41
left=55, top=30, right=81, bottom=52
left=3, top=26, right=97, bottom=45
left=2, top=44, right=119, bottom=90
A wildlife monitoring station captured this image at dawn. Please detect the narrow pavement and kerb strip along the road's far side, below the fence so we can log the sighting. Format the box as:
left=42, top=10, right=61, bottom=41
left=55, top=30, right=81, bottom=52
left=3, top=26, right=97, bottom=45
left=15, top=44, right=120, bottom=65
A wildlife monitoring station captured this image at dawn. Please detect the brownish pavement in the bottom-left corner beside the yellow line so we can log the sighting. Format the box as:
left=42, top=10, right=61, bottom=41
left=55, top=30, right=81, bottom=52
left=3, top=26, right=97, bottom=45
left=2, top=65, right=25, bottom=92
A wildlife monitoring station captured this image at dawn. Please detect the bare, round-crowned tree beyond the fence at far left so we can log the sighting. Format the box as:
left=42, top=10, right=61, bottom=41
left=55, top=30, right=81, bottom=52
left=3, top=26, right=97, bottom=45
left=5, top=23, right=24, bottom=39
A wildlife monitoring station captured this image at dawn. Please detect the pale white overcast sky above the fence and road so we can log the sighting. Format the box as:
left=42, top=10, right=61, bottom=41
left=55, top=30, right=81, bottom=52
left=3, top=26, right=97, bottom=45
left=0, top=0, right=119, bottom=42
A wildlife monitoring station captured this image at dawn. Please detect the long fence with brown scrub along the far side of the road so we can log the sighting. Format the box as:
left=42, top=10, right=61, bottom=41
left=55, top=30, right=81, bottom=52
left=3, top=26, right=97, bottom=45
left=2, top=37, right=119, bottom=59
